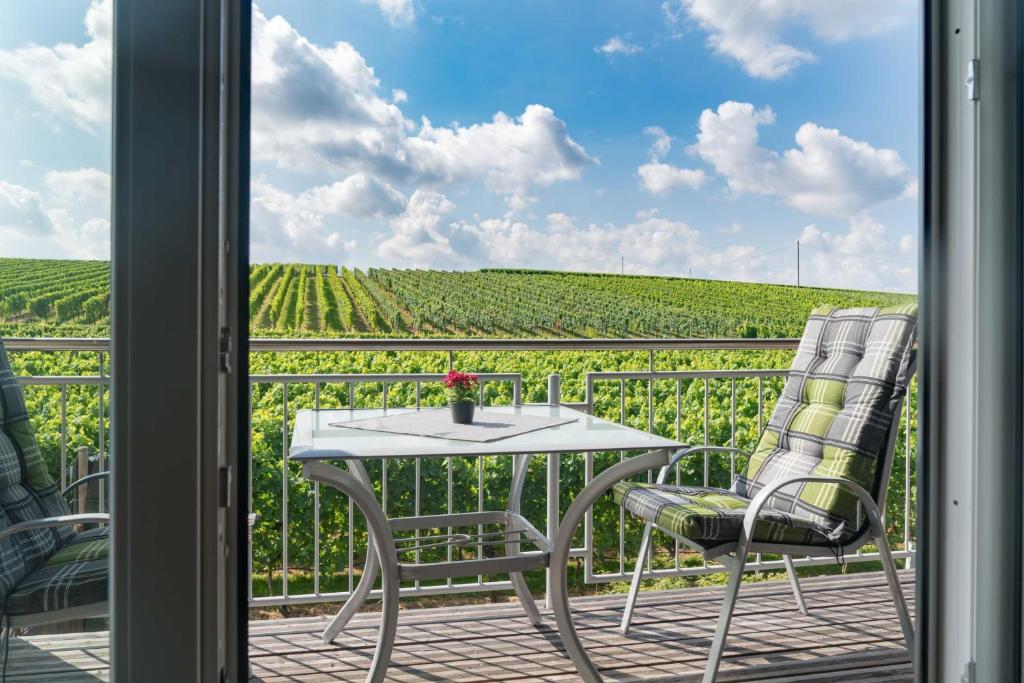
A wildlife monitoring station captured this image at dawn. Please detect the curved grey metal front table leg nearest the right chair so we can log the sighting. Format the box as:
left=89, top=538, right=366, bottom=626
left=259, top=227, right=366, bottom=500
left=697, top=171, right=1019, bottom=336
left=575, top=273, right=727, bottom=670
left=551, top=451, right=670, bottom=682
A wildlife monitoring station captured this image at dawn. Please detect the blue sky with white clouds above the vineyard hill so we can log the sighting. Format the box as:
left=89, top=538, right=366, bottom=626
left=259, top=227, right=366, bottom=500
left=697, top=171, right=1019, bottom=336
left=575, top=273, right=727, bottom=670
left=0, top=0, right=920, bottom=291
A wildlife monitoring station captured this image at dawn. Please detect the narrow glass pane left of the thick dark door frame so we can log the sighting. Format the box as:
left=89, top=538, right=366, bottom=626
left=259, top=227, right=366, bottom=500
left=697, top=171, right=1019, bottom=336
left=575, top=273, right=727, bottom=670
left=0, top=0, right=117, bottom=680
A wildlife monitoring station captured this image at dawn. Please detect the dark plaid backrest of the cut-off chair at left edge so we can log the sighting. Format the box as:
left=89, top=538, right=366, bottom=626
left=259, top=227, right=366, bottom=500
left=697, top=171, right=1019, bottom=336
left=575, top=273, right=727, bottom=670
left=0, top=341, right=74, bottom=599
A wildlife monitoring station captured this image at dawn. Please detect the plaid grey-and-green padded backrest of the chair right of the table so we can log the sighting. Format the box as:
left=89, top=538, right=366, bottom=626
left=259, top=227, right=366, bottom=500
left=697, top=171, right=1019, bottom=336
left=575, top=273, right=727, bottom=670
left=734, top=304, right=918, bottom=541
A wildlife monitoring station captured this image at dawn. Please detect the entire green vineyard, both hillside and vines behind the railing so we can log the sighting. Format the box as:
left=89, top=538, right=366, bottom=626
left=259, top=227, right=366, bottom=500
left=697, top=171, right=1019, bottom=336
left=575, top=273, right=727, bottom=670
left=0, top=259, right=916, bottom=606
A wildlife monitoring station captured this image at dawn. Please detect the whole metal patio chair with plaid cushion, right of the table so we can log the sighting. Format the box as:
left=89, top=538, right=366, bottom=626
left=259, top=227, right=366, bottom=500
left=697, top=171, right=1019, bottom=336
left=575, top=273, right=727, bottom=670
left=612, top=305, right=916, bottom=682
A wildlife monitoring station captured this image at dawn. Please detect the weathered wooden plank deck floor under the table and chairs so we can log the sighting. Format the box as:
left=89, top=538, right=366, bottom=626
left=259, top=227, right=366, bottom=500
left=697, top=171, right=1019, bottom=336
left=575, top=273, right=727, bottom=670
left=14, top=573, right=913, bottom=683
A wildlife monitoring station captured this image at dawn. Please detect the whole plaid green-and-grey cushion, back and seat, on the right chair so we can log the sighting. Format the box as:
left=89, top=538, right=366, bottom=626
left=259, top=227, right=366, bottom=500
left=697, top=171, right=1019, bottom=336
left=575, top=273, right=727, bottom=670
left=612, top=305, right=916, bottom=547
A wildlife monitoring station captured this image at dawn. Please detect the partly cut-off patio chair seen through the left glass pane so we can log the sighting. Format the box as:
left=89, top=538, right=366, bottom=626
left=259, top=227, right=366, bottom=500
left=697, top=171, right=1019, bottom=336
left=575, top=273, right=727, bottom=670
left=0, top=341, right=110, bottom=675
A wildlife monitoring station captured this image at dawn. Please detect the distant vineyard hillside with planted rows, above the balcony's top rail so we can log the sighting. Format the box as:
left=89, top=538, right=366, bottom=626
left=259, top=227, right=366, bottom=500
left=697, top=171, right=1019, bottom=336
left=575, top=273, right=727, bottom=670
left=0, top=259, right=910, bottom=338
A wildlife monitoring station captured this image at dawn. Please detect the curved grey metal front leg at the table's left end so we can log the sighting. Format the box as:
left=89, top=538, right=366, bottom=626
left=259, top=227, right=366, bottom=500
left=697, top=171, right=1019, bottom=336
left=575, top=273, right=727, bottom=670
left=302, top=462, right=398, bottom=683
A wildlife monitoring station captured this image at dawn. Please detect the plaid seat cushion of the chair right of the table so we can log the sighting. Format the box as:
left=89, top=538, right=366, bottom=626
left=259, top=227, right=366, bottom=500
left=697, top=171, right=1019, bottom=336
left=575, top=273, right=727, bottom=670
left=611, top=481, right=844, bottom=548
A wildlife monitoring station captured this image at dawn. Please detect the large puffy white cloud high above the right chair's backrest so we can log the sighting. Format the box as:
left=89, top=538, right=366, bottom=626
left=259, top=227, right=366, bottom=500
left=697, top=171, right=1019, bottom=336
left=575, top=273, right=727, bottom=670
left=690, top=101, right=915, bottom=216
